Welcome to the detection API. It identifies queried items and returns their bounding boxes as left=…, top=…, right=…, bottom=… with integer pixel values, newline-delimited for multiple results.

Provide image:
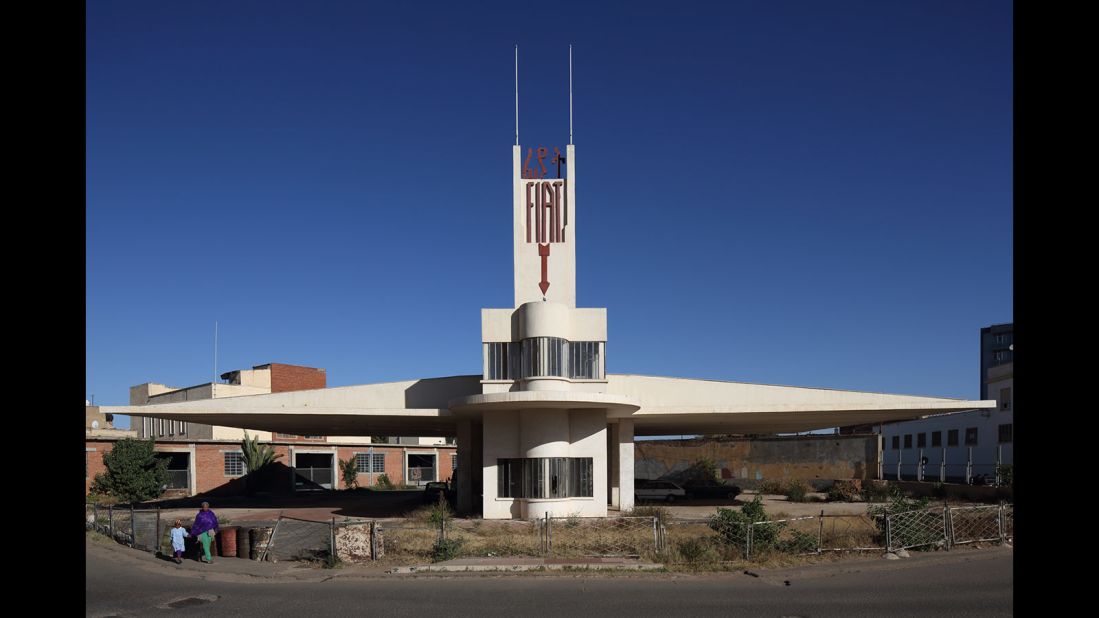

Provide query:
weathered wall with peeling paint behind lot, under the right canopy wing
left=634, top=435, right=878, bottom=485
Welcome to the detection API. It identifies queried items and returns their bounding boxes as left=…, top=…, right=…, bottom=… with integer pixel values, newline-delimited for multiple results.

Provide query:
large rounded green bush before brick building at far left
left=91, top=438, right=168, bottom=503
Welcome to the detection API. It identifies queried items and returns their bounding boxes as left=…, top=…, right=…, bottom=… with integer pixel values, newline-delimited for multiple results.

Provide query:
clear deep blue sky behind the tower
left=86, top=0, right=1013, bottom=424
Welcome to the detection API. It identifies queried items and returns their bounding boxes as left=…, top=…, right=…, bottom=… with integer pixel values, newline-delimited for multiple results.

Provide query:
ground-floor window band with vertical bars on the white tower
left=497, top=457, right=595, bottom=498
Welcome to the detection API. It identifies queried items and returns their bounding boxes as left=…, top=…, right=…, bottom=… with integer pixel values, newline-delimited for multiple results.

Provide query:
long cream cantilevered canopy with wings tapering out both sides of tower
left=100, top=374, right=996, bottom=437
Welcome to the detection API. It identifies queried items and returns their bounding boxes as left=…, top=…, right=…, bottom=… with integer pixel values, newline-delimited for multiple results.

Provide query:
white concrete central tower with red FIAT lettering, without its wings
left=451, top=136, right=637, bottom=519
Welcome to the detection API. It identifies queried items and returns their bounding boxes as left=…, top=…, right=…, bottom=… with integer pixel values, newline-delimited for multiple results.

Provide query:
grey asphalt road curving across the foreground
left=86, top=547, right=1012, bottom=618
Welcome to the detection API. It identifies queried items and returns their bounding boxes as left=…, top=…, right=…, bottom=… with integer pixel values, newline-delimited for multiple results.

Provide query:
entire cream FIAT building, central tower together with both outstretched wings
left=101, top=136, right=996, bottom=519
